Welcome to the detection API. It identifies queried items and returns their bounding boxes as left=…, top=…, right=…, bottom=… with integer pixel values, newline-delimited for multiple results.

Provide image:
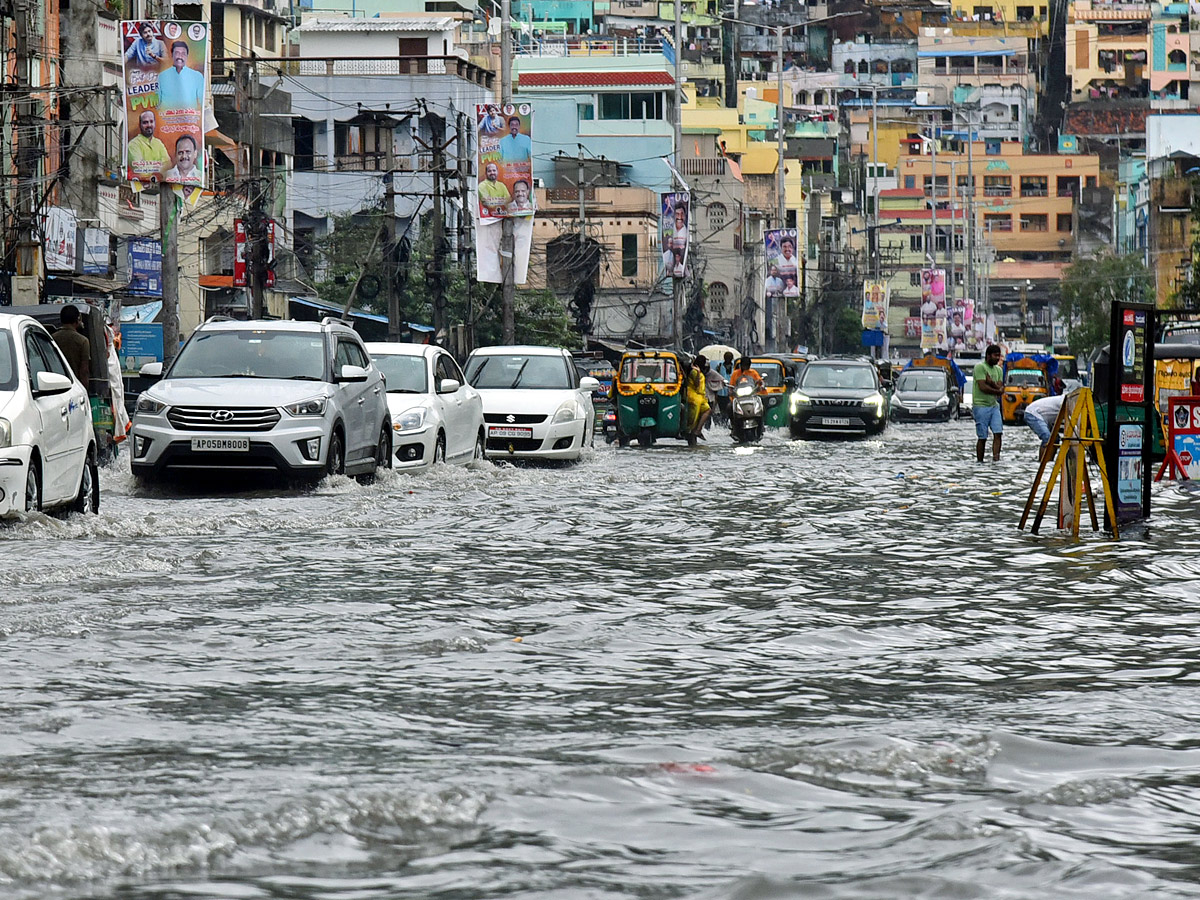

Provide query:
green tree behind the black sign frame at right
left=1060, top=254, right=1154, bottom=354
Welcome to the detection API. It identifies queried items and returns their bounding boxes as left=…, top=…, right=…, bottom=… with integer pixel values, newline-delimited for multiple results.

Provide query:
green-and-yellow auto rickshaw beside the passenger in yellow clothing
left=612, top=350, right=696, bottom=448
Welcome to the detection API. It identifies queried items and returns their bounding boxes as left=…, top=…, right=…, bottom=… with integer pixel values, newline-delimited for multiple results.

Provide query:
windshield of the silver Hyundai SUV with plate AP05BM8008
left=169, top=329, right=325, bottom=382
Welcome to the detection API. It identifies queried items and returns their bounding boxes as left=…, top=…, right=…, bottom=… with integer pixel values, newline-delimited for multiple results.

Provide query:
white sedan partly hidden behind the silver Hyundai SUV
left=366, top=343, right=484, bottom=469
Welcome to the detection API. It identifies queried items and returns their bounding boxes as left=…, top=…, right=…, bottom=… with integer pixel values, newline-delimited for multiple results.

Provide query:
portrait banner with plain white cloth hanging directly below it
left=475, top=103, right=535, bottom=222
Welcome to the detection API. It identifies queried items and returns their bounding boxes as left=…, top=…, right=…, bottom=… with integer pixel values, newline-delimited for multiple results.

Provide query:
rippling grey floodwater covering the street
left=0, top=421, right=1200, bottom=900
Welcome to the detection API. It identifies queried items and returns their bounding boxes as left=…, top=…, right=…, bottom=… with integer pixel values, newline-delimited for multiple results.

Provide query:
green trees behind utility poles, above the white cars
left=316, top=211, right=580, bottom=347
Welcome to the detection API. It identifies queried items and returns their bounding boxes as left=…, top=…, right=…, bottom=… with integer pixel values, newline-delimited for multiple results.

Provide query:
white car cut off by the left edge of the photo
left=0, top=314, right=100, bottom=517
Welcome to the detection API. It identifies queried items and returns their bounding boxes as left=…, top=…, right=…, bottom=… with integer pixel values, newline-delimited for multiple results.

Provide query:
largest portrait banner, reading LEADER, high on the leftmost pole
left=121, top=19, right=209, bottom=187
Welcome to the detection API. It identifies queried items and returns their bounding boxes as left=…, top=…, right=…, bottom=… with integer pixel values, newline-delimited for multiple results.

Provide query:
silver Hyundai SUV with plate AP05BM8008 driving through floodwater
left=130, top=317, right=391, bottom=479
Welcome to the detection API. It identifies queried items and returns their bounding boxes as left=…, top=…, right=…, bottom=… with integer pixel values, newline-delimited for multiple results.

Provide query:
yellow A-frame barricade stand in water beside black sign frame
left=1016, top=388, right=1120, bottom=538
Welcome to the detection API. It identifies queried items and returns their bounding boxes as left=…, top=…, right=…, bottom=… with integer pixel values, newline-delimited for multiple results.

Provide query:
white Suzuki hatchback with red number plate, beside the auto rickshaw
left=467, top=347, right=600, bottom=460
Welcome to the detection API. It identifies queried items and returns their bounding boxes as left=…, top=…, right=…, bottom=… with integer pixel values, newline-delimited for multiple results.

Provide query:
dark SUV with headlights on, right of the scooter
left=788, top=359, right=888, bottom=438
